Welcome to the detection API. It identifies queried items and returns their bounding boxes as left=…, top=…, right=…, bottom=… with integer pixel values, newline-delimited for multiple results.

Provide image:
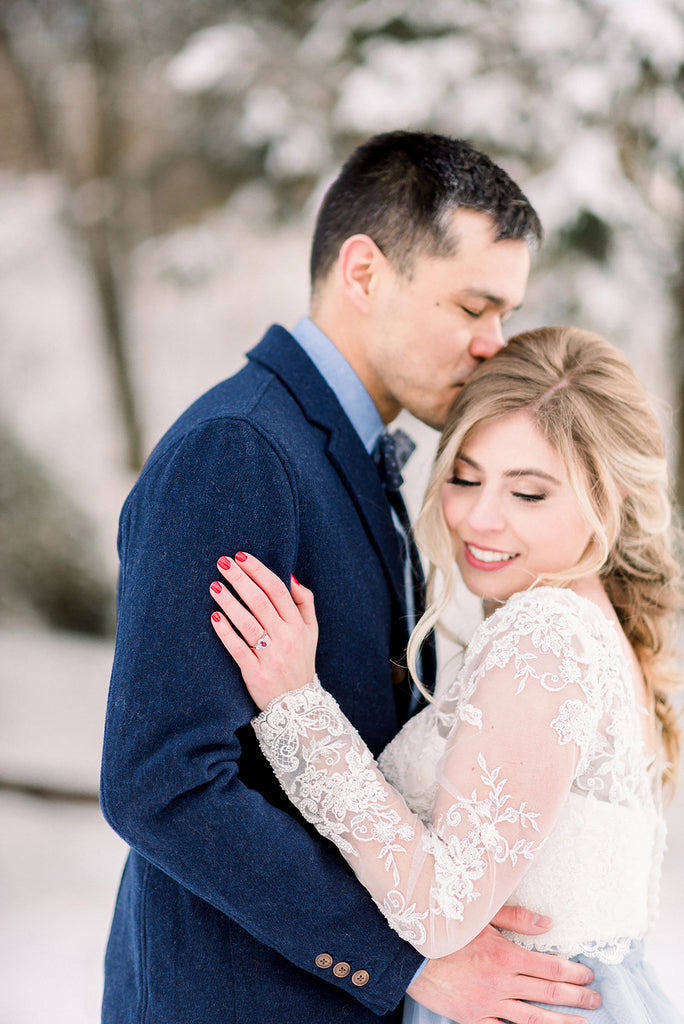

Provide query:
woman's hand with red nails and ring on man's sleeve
left=210, top=551, right=318, bottom=711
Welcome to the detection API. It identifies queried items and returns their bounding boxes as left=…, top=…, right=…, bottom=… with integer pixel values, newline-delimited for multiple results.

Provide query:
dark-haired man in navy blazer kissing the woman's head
left=102, top=132, right=595, bottom=1024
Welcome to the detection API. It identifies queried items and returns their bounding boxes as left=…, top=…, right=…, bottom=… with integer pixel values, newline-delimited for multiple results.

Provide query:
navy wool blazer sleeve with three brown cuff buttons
left=101, top=419, right=422, bottom=1013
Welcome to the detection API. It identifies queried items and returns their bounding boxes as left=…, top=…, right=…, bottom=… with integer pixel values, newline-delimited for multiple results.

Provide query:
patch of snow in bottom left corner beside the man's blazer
left=0, top=793, right=126, bottom=1024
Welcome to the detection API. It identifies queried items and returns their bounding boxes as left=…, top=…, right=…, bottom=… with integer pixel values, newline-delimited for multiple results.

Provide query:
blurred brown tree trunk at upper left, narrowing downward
left=0, top=0, right=142, bottom=470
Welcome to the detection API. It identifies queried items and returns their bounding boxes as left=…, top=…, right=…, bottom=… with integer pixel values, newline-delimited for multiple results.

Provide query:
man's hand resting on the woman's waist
left=409, top=906, right=601, bottom=1024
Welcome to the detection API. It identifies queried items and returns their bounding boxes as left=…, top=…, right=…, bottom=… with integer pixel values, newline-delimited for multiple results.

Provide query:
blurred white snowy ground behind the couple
left=0, top=175, right=684, bottom=1024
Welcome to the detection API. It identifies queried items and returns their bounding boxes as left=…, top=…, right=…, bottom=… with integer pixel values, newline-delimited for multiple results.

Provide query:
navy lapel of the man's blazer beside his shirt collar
left=248, top=326, right=405, bottom=611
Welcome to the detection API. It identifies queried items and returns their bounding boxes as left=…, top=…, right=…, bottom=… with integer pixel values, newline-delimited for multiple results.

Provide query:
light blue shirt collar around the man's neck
left=290, top=316, right=385, bottom=455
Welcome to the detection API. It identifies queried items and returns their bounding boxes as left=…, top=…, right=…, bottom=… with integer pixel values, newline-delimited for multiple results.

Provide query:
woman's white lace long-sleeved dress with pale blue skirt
left=254, top=587, right=680, bottom=1024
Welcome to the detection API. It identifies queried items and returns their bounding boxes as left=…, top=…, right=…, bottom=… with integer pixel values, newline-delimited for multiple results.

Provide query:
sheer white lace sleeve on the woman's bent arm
left=254, top=589, right=596, bottom=957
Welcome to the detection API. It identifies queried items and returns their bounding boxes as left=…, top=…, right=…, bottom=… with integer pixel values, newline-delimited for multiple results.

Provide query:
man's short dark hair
left=310, top=131, right=542, bottom=288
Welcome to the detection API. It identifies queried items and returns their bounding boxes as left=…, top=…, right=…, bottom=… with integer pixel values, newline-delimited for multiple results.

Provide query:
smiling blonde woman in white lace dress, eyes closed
left=206, top=328, right=680, bottom=1024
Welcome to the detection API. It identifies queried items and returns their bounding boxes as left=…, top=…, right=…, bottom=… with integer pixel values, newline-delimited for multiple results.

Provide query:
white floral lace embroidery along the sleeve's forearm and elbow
left=255, top=680, right=543, bottom=944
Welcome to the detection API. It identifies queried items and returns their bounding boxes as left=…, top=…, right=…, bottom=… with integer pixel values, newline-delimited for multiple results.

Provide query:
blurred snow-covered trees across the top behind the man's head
left=4, top=0, right=684, bottom=491
